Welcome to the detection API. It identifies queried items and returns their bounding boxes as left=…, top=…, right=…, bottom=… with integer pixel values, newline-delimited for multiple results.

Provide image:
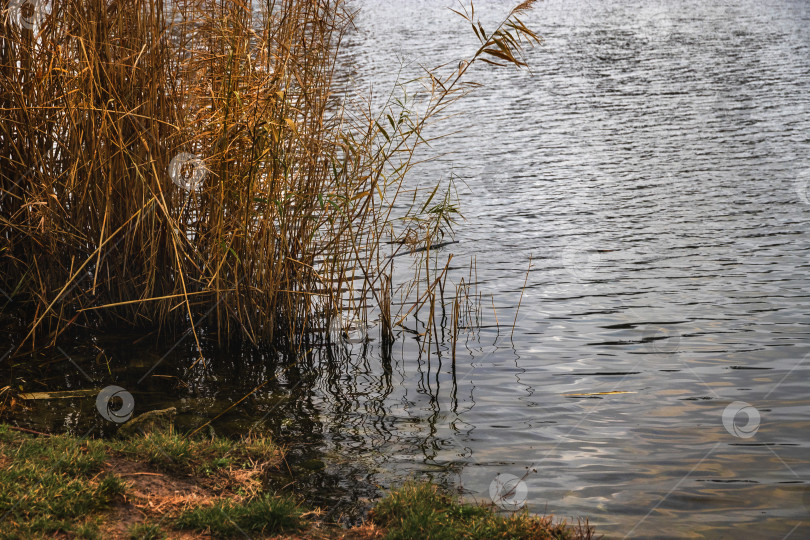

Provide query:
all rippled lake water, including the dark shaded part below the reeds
left=6, top=0, right=810, bottom=539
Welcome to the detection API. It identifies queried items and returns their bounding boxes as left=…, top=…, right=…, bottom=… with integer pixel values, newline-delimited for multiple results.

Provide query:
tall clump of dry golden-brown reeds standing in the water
left=0, top=0, right=538, bottom=351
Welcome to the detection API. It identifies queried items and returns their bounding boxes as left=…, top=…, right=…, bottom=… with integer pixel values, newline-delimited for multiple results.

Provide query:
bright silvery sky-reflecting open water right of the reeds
left=334, top=0, right=810, bottom=538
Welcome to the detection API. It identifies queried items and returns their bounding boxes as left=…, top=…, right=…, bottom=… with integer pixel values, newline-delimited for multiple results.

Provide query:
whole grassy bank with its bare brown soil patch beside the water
left=0, top=425, right=591, bottom=540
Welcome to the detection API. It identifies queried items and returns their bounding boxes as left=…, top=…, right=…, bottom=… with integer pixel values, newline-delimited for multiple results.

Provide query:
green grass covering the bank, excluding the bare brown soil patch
left=0, top=424, right=592, bottom=540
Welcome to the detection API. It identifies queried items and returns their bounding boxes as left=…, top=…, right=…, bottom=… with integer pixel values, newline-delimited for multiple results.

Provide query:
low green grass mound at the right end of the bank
left=371, top=483, right=591, bottom=540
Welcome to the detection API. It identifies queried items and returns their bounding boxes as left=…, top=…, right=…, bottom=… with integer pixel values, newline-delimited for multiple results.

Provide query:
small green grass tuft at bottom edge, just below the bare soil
left=174, top=494, right=302, bottom=538
